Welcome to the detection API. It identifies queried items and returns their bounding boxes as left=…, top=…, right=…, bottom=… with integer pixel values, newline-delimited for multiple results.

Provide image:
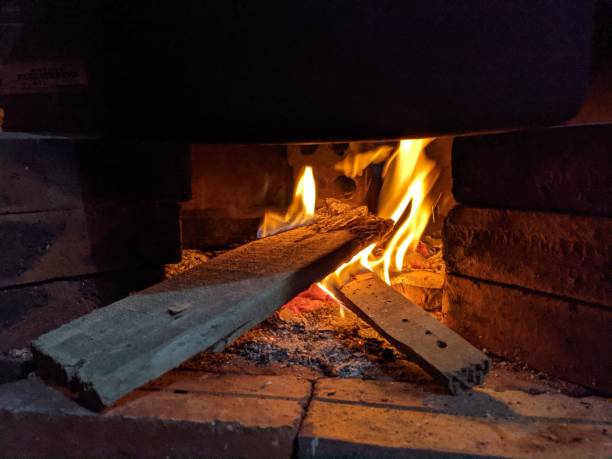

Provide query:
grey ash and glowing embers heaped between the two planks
left=225, top=302, right=429, bottom=380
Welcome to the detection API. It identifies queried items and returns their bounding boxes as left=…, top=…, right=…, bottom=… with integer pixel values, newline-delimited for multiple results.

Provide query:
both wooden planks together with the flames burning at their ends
left=33, top=135, right=489, bottom=407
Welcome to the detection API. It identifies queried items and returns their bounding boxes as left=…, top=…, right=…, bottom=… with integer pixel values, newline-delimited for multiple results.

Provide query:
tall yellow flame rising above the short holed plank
left=321, top=139, right=439, bottom=296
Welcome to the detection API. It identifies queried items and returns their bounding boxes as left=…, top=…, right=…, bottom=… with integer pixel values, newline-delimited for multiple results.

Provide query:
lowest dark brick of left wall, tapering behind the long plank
left=0, top=268, right=163, bottom=353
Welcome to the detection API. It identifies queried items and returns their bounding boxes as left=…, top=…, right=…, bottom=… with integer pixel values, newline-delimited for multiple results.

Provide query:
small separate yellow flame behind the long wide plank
left=257, top=166, right=317, bottom=237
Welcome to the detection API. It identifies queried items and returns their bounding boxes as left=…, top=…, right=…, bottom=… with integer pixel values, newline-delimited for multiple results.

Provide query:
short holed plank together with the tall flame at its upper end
left=310, top=139, right=489, bottom=393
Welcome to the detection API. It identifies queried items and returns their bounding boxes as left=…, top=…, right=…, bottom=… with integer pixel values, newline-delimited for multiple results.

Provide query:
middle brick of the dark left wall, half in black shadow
left=0, top=203, right=181, bottom=287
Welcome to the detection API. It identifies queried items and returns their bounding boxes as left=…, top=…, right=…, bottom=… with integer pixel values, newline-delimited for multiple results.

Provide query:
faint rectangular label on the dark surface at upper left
left=0, top=62, right=87, bottom=96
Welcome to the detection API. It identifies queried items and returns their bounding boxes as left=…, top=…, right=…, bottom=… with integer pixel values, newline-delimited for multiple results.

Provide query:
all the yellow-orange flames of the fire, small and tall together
left=258, top=139, right=440, bottom=317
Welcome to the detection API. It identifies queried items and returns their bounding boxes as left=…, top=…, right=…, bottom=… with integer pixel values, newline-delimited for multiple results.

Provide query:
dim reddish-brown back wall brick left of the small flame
left=181, top=144, right=293, bottom=249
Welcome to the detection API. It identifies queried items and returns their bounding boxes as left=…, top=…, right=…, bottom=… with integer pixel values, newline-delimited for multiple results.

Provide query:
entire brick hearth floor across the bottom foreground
left=0, top=369, right=612, bottom=458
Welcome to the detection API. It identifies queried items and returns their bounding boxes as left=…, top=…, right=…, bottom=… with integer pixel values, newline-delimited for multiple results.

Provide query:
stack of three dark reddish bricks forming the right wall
left=443, top=125, right=612, bottom=392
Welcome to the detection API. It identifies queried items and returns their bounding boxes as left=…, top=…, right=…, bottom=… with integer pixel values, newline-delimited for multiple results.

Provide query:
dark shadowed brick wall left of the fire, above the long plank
left=0, top=133, right=191, bottom=379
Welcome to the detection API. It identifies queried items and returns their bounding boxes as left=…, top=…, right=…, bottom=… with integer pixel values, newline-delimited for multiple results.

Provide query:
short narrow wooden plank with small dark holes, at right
left=339, top=274, right=490, bottom=394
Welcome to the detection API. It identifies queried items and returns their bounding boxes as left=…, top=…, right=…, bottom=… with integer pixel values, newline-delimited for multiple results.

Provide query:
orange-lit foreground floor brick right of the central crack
left=298, top=379, right=612, bottom=458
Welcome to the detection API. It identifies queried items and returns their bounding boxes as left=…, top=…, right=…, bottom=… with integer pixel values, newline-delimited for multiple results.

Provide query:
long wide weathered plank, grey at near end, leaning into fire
left=33, top=212, right=389, bottom=407
